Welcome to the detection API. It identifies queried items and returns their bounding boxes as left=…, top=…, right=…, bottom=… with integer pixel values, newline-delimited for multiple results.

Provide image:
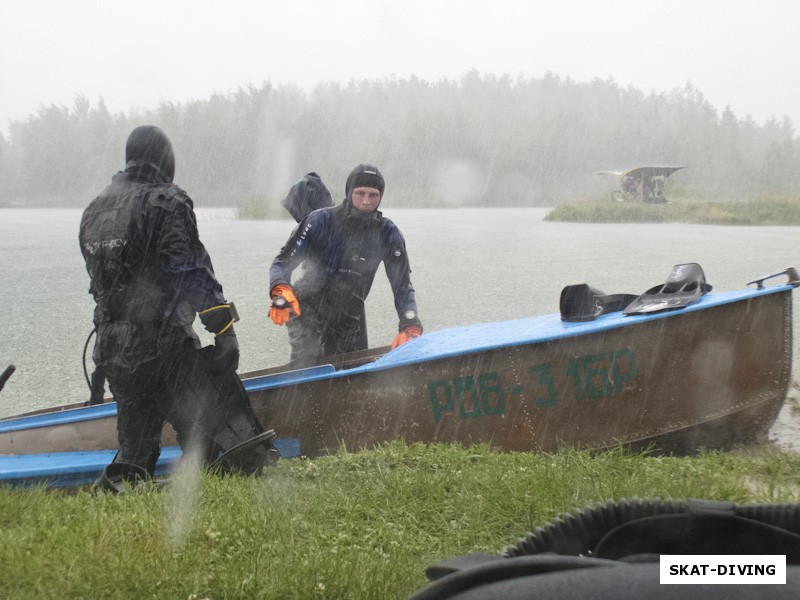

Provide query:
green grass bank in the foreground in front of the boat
left=0, top=443, right=800, bottom=599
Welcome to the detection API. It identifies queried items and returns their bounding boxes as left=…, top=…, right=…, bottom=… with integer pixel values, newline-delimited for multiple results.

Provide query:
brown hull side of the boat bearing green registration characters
left=250, top=292, right=792, bottom=456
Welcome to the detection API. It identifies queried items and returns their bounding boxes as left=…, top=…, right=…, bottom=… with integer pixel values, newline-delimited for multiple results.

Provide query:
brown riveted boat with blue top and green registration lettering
left=0, top=269, right=797, bottom=490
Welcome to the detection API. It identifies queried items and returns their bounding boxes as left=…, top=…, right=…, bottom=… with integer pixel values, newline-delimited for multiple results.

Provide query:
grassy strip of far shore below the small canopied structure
left=545, top=196, right=800, bottom=225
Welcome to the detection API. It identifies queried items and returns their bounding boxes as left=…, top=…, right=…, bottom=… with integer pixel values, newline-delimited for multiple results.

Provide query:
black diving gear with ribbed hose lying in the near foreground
left=410, top=498, right=800, bottom=600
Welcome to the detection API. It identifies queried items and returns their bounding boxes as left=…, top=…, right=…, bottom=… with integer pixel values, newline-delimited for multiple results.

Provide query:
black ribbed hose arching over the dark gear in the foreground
left=504, top=498, right=800, bottom=558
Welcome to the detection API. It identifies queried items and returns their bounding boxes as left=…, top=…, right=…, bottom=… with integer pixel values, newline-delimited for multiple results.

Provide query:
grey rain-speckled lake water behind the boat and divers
left=0, top=206, right=800, bottom=451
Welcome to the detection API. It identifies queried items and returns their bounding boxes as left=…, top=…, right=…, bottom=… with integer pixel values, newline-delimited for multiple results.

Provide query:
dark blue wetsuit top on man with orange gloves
left=270, top=199, right=421, bottom=331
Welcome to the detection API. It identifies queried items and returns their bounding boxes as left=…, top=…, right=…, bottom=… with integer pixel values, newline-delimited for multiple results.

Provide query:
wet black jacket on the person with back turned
left=79, top=160, right=225, bottom=371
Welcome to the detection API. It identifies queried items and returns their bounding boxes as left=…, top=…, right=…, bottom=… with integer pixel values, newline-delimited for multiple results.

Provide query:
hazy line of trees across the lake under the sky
left=0, top=71, right=800, bottom=207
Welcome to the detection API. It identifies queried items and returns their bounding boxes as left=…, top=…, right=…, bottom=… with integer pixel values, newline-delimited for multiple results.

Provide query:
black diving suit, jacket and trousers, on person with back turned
left=79, top=161, right=225, bottom=474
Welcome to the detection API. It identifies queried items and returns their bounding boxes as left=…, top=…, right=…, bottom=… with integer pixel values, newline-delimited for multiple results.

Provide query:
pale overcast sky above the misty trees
left=0, top=0, right=800, bottom=132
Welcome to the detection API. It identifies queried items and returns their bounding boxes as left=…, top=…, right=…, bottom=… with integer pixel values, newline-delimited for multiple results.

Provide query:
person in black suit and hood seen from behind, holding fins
left=79, top=126, right=272, bottom=476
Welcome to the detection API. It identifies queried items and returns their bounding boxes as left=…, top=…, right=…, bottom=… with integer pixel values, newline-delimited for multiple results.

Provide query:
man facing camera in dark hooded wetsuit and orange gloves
left=270, top=164, right=422, bottom=367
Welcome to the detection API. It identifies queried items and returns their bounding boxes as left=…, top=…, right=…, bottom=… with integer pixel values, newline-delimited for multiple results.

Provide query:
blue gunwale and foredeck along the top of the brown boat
left=0, top=284, right=794, bottom=433
